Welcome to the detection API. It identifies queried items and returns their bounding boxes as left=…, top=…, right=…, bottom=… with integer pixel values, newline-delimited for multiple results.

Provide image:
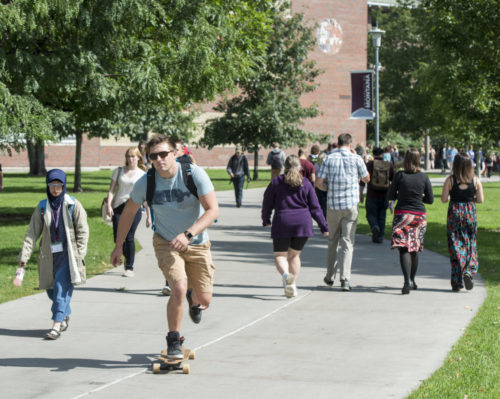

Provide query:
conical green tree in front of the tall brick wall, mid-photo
left=201, top=4, right=320, bottom=179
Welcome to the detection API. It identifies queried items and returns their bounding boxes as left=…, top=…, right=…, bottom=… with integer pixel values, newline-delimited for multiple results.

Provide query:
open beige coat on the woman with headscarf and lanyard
left=18, top=194, right=89, bottom=290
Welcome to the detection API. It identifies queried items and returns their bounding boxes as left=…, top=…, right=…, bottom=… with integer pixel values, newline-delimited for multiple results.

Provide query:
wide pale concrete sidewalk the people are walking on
left=0, top=189, right=486, bottom=399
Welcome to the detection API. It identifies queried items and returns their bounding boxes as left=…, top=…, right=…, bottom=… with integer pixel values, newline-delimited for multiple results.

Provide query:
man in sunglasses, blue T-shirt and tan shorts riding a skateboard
left=110, top=134, right=219, bottom=359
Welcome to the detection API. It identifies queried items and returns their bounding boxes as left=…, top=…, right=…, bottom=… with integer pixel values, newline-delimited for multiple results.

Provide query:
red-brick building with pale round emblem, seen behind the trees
left=0, top=0, right=396, bottom=170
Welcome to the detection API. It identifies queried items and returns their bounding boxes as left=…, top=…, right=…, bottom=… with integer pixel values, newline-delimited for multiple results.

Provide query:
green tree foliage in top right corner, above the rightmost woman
left=422, top=0, right=500, bottom=144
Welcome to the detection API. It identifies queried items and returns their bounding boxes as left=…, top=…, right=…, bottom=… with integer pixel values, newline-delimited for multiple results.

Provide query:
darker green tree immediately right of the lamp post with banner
left=368, top=0, right=437, bottom=142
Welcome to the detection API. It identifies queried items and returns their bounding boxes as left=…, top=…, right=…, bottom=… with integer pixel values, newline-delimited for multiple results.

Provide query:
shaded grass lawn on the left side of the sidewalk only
left=0, top=169, right=271, bottom=303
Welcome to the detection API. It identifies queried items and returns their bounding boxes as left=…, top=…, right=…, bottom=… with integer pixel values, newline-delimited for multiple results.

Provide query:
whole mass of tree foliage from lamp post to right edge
left=369, top=0, right=500, bottom=144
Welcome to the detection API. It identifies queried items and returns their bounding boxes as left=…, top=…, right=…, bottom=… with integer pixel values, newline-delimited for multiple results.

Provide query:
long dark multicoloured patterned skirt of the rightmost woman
left=446, top=201, right=479, bottom=289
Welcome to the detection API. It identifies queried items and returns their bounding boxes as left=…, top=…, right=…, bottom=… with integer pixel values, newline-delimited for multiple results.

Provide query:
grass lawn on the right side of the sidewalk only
left=357, top=183, right=500, bottom=399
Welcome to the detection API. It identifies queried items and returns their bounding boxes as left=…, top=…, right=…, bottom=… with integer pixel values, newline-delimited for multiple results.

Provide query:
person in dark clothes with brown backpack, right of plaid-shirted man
left=365, top=147, right=394, bottom=244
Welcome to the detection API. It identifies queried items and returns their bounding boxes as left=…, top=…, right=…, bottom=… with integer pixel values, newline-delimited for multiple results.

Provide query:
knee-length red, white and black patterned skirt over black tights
left=391, top=213, right=427, bottom=252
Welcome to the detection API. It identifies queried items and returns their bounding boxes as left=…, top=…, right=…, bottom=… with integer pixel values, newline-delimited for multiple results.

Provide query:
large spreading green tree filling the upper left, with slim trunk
left=0, top=0, right=271, bottom=187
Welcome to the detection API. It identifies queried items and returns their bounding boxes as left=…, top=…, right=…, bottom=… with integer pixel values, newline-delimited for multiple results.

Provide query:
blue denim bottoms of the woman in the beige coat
left=47, top=258, right=73, bottom=322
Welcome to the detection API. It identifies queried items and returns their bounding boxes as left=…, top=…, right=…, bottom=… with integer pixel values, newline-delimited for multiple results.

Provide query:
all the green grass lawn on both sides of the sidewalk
left=0, top=169, right=500, bottom=399
